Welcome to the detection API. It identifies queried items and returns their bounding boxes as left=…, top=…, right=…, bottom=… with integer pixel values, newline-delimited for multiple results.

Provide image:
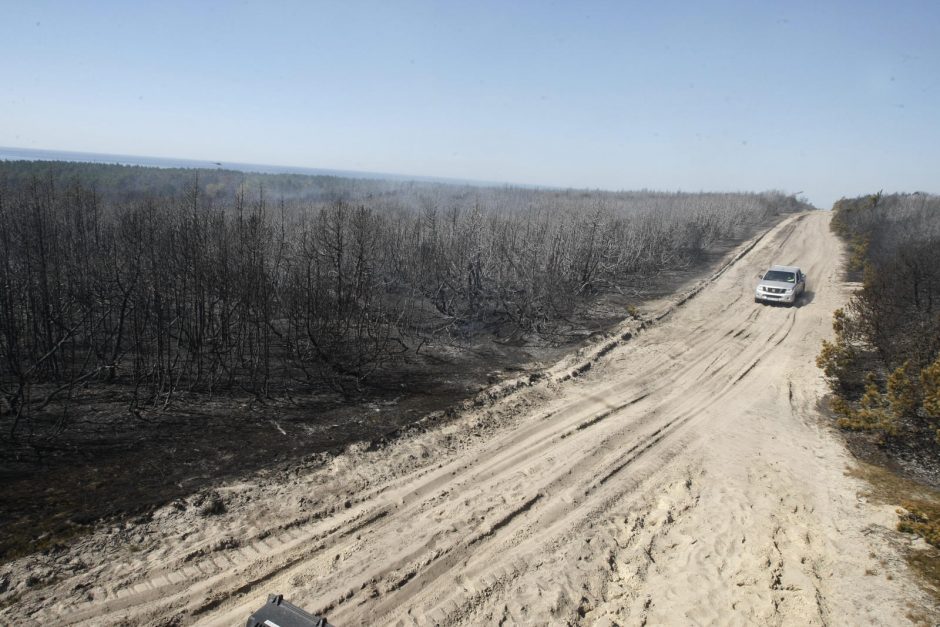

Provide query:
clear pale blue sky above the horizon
left=0, top=0, right=940, bottom=208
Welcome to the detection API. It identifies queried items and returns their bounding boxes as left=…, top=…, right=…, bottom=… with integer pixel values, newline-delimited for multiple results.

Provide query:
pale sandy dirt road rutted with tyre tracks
left=0, top=212, right=936, bottom=626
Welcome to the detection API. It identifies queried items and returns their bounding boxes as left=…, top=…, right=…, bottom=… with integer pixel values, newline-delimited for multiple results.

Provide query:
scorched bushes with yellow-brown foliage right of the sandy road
left=817, top=193, right=940, bottom=450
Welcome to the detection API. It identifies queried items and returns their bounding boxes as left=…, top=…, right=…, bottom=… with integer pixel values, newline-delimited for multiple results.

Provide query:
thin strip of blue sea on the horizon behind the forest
left=0, top=146, right=492, bottom=186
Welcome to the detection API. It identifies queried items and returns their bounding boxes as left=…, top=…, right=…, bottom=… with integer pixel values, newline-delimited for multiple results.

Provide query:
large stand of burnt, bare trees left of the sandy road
left=0, top=162, right=808, bottom=440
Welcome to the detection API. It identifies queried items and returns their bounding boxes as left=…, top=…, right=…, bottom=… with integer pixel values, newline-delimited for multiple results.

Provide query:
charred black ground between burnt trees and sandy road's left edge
left=0, top=232, right=756, bottom=563
